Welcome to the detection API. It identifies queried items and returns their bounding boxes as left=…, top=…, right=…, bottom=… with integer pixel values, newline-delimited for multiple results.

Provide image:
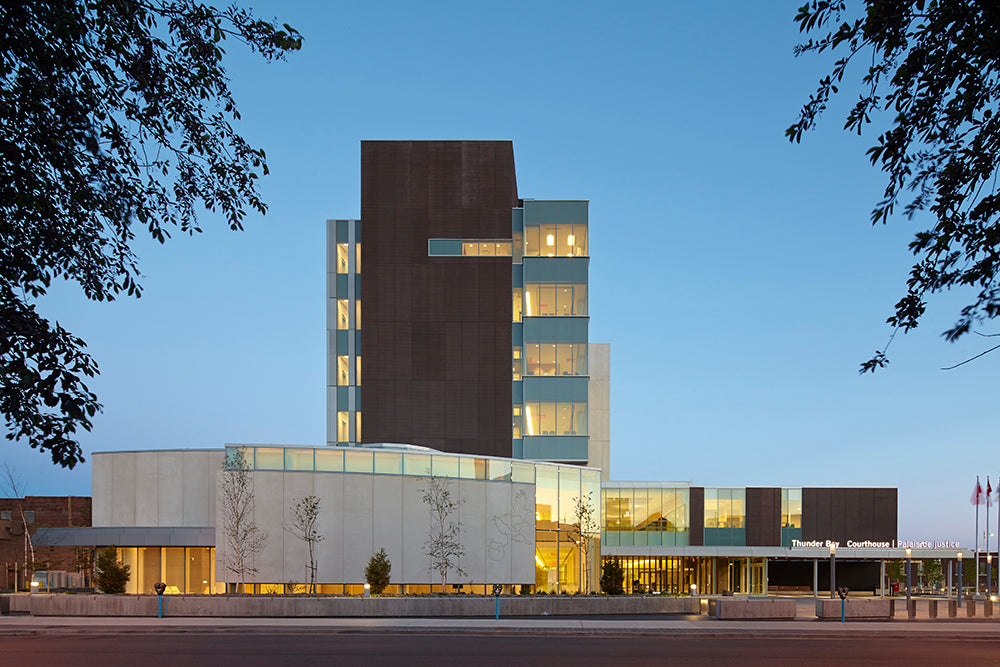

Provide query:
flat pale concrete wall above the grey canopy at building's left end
left=91, top=449, right=224, bottom=528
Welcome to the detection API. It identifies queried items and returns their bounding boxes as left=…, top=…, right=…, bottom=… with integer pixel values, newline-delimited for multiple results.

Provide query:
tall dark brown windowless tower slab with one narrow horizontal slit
left=360, top=141, right=518, bottom=456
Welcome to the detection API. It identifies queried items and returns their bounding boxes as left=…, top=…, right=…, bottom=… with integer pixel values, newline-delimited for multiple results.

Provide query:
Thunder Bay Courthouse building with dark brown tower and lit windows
left=41, top=141, right=936, bottom=594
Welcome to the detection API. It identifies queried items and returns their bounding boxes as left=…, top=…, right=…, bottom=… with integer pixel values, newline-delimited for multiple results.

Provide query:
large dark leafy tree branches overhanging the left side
left=0, top=0, right=302, bottom=468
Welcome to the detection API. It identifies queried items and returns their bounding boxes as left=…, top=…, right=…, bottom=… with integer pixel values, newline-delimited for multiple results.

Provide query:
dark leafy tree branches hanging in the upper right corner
left=786, top=0, right=1000, bottom=373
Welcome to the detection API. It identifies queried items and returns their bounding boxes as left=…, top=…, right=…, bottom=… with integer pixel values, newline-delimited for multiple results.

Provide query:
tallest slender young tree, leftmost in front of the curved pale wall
left=220, top=449, right=267, bottom=592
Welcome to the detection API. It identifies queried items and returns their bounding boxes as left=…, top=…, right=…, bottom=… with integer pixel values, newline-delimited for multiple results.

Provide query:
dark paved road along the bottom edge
left=0, top=631, right=1000, bottom=667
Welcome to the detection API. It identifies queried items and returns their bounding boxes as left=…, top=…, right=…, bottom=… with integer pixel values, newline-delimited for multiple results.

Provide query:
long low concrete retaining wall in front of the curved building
left=23, top=594, right=701, bottom=617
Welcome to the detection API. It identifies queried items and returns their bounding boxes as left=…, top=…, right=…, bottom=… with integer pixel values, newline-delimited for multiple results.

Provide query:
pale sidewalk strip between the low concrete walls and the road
left=0, top=616, right=1000, bottom=640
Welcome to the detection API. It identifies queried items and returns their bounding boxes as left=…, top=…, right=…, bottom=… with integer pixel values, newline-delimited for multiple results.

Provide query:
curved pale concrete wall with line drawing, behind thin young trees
left=215, top=471, right=535, bottom=584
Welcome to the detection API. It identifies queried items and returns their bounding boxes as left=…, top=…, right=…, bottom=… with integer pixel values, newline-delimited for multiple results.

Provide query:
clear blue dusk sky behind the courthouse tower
left=0, top=0, right=1000, bottom=546
